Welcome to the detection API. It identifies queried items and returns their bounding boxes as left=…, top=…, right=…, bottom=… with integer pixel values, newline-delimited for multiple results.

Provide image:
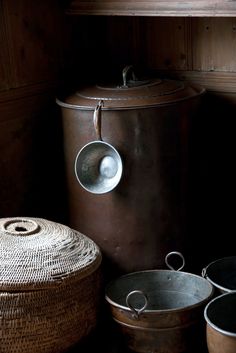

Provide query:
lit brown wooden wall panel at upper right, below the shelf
left=192, top=18, right=236, bottom=72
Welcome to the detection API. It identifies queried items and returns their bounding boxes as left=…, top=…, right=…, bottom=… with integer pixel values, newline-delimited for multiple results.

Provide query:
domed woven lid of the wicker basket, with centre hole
left=0, top=217, right=101, bottom=291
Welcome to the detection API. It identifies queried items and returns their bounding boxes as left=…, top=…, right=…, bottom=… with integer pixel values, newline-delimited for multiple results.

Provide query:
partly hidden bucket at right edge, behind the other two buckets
left=202, top=256, right=236, bottom=294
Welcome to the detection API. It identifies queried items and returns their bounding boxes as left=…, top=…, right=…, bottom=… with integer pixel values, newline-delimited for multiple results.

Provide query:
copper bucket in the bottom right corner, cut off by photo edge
left=204, top=291, right=236, bottom=353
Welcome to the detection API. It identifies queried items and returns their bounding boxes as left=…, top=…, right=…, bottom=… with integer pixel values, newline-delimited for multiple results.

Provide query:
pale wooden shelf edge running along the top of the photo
left=66, top=0, right=236, bottom=17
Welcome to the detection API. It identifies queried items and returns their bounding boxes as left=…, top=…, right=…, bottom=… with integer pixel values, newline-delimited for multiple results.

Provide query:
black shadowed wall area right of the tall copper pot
left=188, top=93, right=236, bottom=273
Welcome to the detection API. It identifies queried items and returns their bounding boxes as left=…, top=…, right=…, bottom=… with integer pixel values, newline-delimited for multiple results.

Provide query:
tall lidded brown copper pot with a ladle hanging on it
left=57, top=67, right=204, bottom=274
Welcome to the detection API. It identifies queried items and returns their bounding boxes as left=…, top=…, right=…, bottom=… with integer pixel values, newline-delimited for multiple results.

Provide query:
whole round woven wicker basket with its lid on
left=0, top=217, right=101, bottom=353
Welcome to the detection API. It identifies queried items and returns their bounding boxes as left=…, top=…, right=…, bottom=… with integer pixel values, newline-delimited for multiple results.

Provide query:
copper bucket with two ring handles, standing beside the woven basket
left=105, top=252, right=214, bottom=353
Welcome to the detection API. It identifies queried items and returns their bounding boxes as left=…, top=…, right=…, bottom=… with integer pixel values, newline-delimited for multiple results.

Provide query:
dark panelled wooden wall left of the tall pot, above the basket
left=0, top=0, right=70, bottom=222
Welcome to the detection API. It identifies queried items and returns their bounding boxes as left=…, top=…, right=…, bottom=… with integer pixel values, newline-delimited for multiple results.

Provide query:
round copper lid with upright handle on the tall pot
left=57, top=66, right=205, bottom=109
